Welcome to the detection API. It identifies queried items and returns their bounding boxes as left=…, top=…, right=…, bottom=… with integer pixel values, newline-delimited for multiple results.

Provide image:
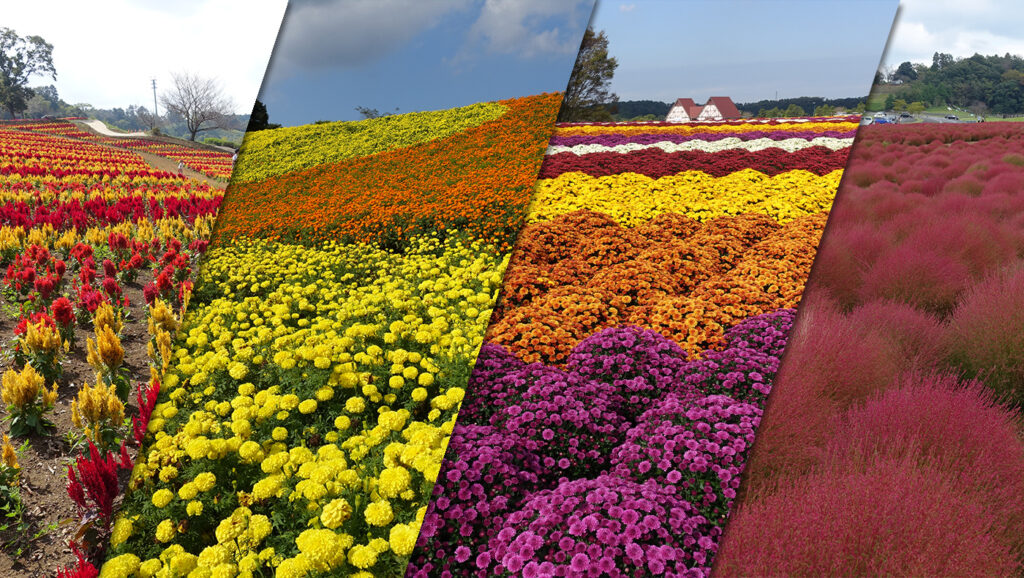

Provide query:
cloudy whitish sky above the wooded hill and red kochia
left=884, top=0, right=1024, bottom=67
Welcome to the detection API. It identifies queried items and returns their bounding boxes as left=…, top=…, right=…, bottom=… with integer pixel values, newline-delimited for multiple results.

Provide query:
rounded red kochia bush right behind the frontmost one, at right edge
left=825, top=372, right=1024, bottom=553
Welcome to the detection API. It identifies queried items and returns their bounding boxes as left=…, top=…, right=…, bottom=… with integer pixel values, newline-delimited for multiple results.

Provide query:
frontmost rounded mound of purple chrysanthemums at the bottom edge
left=487, top=474, right=721, bottom=578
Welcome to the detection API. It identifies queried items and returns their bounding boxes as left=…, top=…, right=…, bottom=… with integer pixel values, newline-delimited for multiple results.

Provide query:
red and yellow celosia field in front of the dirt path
left=0, top=123, right=222, bottom=569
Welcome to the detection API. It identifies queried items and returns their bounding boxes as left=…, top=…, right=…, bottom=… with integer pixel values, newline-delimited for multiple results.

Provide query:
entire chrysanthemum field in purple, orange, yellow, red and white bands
left=408, top=117, right=857, bottom=577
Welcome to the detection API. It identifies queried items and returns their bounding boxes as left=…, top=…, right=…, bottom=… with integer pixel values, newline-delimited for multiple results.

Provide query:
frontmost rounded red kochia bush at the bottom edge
left=714, top=459, right=1021, bottom=578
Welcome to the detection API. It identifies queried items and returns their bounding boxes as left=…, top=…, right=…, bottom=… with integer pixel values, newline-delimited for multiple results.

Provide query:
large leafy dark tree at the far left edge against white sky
left=0, top=28, right=57, bottom=118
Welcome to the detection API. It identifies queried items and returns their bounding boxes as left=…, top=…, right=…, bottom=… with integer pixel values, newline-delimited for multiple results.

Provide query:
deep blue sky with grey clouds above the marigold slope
left=260, top=0, right=594, bottom=126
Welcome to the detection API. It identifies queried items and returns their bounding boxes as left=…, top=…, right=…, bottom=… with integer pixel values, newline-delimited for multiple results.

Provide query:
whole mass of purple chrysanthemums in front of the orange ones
left=407, top=309, right=794, bottom=578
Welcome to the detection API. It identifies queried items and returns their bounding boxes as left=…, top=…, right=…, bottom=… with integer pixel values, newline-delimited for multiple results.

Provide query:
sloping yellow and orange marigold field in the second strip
left=102, top=94, right=560, bottom=578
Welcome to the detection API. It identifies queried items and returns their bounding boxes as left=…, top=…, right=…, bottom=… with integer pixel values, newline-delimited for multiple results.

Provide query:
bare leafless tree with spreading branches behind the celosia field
left=160, top=73, right=234, bottom=140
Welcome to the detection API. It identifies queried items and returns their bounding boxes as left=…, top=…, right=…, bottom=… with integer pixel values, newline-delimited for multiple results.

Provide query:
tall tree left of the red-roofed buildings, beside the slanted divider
left=558, top=27, right=618, bottom=122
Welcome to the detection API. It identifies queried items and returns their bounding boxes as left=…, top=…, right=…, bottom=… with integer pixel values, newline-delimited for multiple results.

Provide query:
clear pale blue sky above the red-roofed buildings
left=592, top=0, right=897, bottom=104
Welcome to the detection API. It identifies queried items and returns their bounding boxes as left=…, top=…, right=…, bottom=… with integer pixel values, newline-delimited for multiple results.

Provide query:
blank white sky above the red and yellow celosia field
left=0, top=0, right=288, bottom=114
